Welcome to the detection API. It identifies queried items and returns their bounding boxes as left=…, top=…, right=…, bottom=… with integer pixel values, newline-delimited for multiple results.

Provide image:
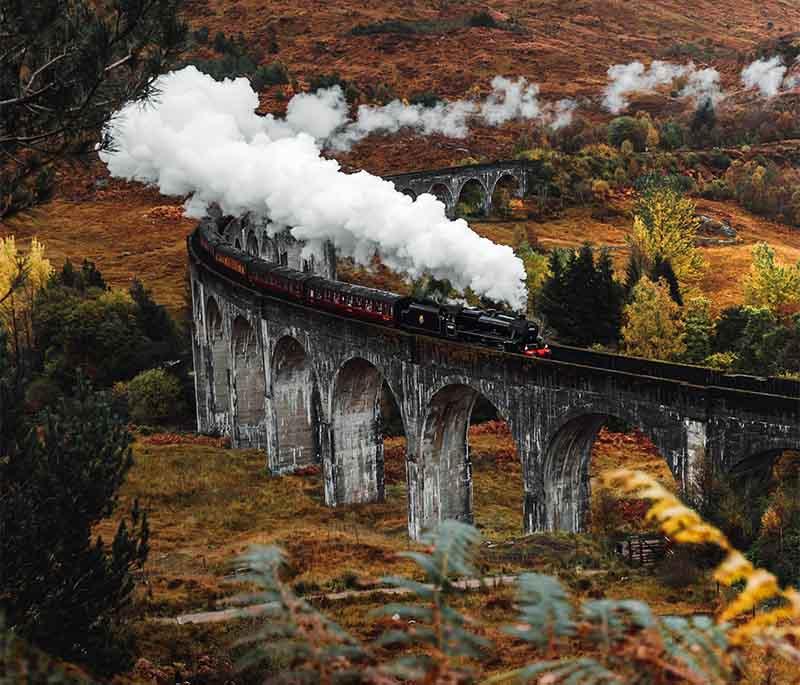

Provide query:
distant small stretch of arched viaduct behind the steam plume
left=384, top=160, right=540, bottom=217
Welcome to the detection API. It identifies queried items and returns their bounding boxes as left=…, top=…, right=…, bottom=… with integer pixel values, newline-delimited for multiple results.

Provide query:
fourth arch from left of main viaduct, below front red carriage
left=330, top=357, right=396, bottom=504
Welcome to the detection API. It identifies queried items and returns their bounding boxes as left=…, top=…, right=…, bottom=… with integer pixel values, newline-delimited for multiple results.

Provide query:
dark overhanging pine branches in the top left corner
left=0, top=0, right=185, bottom=217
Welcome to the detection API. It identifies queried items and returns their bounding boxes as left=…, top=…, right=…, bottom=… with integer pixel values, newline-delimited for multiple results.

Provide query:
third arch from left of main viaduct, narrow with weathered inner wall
left=270, top=335, right=321, bottom=472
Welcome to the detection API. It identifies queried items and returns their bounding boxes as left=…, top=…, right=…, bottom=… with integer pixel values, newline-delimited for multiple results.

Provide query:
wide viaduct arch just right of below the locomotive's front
left=528, top=403, right=687, bottom=533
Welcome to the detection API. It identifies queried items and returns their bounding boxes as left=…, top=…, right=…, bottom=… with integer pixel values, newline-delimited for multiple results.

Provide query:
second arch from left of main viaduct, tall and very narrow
left=231, top=316, right=266, bottom=440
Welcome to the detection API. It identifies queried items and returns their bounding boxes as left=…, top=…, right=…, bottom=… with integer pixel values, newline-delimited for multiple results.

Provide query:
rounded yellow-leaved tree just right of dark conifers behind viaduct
left=622, top=277, right=686, bottom=361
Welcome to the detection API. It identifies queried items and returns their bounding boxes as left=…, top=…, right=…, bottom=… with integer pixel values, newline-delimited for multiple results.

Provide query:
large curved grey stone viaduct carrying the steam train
left=189, top=203, right=800, bottom=539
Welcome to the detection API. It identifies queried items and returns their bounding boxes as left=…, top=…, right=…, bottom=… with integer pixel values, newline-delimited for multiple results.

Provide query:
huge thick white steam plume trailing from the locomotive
left=100, top=67, right=525, bottom=309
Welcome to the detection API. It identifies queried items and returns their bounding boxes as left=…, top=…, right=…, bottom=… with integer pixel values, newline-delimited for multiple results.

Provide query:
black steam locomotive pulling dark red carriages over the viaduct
left=194, top=222, right=550, bottom=357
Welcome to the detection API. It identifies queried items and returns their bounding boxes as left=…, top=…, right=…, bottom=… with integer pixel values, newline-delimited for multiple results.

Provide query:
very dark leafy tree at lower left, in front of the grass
left=0, top=376, right=148, bottom=673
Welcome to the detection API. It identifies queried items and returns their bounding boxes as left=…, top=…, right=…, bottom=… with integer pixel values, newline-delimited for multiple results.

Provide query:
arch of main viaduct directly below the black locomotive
left=419, top=382, right=521, bottom=528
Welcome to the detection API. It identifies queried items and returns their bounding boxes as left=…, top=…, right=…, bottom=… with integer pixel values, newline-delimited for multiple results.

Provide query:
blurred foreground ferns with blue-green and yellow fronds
left=234, top=471, right=800, bottom=685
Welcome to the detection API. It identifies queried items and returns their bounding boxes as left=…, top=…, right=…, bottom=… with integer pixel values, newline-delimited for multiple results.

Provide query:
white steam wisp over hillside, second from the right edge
left=603, top=60, right=724, bottom=114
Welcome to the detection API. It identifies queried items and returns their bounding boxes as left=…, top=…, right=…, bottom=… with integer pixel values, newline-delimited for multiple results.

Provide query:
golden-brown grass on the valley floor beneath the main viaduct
left=111, top=422, right=736, bottom=673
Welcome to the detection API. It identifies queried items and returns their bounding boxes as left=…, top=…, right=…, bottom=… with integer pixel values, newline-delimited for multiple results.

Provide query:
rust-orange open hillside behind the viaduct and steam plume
left=6, top=0, right=800, bottom=310
